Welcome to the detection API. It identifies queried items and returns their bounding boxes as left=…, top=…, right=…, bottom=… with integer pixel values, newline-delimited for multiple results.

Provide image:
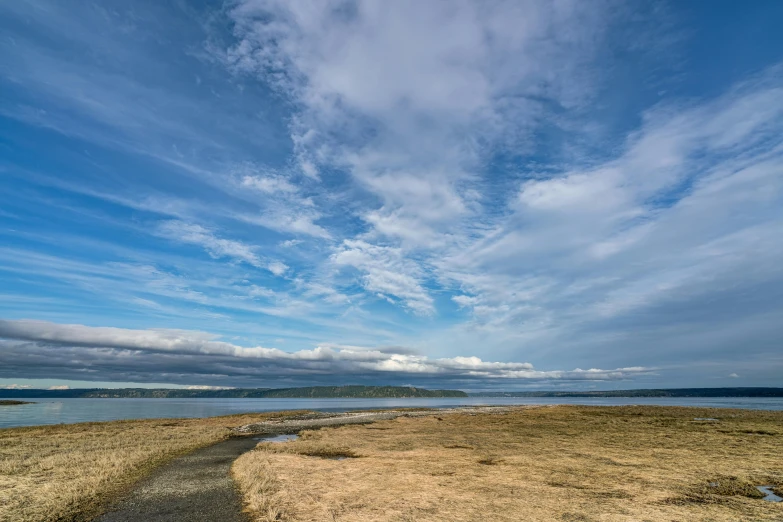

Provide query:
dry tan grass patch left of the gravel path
left=0, top=412, right=310, bottom=522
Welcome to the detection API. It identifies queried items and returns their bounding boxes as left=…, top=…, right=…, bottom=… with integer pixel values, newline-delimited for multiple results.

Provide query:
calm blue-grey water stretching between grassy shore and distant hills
left=0, top=397, right=783, bottom=428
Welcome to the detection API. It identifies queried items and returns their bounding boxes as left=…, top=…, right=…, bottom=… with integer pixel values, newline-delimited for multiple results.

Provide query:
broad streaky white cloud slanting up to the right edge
left=433, top=69, right=783, bottom=344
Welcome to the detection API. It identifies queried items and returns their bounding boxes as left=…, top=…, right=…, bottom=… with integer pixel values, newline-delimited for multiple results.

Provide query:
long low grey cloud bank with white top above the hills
left=0, top=320, right=650, bottom=386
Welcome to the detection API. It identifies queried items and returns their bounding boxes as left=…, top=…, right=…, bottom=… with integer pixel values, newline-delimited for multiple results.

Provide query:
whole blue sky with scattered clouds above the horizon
left=0, top=0, right=783, bottom=391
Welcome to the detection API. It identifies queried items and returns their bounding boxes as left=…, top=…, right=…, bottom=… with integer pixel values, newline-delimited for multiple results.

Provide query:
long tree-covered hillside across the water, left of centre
left=0, top=386, right=468, bottom=399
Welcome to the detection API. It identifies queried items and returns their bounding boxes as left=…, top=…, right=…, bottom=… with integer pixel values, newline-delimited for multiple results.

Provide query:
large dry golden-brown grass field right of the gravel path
left=233, top=406, right=783, bottom=522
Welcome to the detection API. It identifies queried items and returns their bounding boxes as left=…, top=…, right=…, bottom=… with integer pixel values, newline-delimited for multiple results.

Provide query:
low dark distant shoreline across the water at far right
left=470, top=388, right=783, bottom=397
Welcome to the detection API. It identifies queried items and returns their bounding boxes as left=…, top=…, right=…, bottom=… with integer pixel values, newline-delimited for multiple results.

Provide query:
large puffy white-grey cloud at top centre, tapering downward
left=220, top=0, right=611, bottom=248
